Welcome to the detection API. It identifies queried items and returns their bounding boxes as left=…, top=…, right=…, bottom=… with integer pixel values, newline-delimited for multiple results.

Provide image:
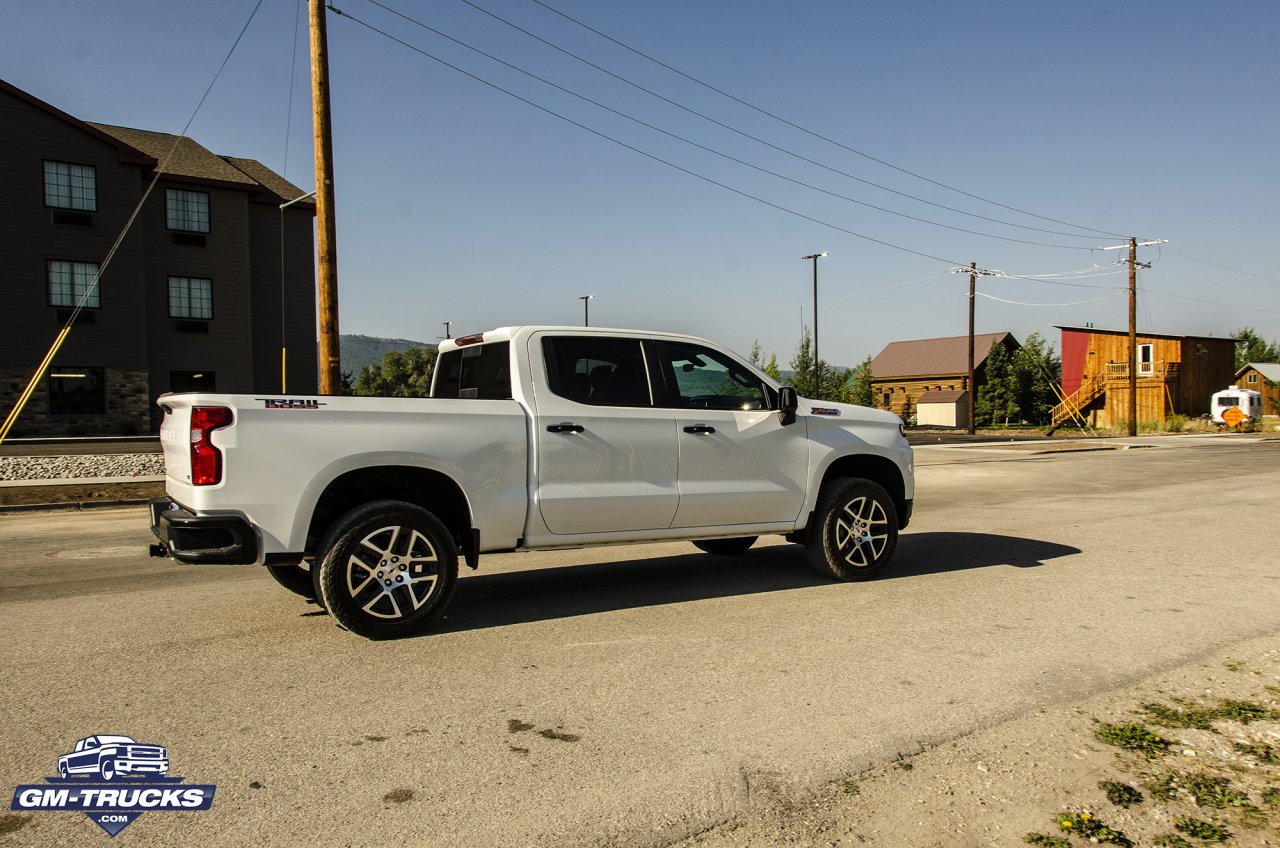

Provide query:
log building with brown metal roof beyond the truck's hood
left=872, top=333, right=1021, bottom=427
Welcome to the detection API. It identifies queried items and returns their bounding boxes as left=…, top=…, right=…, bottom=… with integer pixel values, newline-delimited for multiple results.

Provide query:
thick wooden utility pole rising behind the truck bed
left=307, top=0, right=342, bottom=395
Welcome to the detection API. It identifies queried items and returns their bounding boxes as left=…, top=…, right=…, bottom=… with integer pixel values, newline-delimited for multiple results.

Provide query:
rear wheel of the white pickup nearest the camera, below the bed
left=312, top=501, right=458, bottom=639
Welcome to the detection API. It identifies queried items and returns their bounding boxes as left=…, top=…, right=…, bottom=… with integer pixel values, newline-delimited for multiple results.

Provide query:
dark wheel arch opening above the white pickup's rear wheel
left=306, top=465, right=477, bottom=561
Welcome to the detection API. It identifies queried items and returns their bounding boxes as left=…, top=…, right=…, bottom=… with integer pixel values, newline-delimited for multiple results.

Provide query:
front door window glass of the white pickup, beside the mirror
left=662, top=342, right=769, bottom=410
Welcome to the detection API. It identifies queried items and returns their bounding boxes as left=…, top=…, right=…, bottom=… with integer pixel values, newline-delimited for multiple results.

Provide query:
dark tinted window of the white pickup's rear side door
left=543, top=336, right=653, bottom=406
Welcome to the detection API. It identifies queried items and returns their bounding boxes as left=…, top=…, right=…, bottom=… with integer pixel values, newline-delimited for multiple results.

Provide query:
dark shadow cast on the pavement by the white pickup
left=433, top=533, right=1080, bottom=633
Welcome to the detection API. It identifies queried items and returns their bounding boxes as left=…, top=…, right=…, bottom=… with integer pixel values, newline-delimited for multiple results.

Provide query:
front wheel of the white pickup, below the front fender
left=806, top=478, right=897, bottom=580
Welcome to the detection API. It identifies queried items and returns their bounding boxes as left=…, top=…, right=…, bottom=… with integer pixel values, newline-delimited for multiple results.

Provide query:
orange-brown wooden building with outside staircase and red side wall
left=1052, top=327, right=1235, bottom=429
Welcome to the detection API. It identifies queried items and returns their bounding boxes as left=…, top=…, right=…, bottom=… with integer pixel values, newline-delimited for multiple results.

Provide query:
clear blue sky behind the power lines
left=0, top=0, right=1280, bottom=365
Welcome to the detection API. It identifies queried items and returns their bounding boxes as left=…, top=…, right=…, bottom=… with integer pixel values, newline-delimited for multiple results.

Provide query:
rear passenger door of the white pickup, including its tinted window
left=529, top=333, right=680, bottom=535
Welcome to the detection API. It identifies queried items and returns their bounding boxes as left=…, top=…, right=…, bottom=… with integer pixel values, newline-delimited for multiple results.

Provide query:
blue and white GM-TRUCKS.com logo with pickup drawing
left=9, top=733, right=216, bottom=836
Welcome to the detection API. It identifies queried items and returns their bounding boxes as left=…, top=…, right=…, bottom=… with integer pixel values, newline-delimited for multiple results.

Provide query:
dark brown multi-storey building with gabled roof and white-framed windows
left=0, top=81, right=317, bottom=437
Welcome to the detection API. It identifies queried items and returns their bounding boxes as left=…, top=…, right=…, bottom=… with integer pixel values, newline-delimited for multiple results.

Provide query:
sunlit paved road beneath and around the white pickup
left=0, top=437, right=1280, bottom=848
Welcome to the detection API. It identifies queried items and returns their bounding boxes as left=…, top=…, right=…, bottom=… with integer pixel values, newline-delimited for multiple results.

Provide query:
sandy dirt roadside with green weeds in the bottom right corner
left=678, top=639, right=1280, bottom=848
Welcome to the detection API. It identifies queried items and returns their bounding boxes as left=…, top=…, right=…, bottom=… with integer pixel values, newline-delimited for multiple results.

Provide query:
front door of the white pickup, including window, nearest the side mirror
left=650, top=341, right=809, bottom=528
